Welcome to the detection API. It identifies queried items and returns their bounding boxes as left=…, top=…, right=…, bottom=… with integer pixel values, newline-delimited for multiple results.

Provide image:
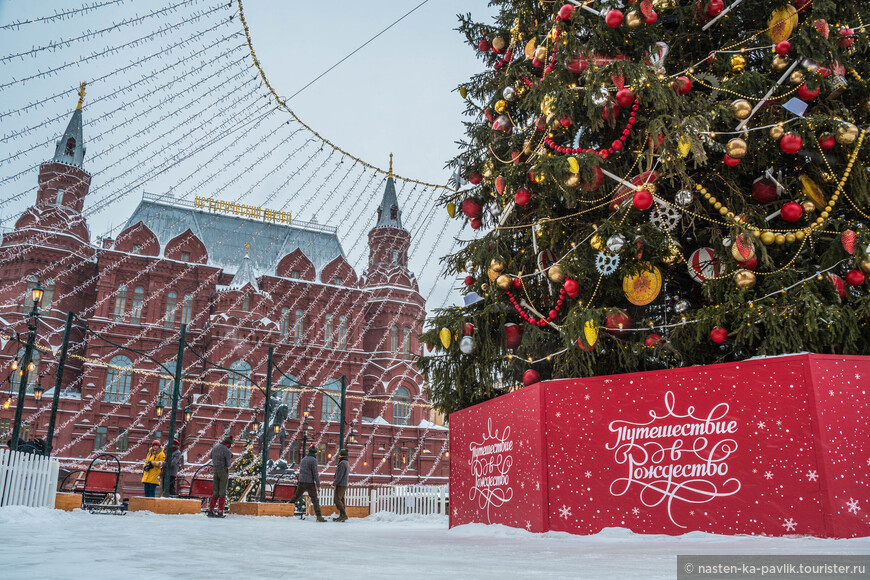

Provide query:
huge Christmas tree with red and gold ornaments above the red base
left=420, top=0, right=870, bottom=413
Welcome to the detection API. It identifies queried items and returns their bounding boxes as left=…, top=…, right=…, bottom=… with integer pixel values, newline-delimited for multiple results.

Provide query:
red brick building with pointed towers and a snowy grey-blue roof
left=0, top=99, right=449, bottom=488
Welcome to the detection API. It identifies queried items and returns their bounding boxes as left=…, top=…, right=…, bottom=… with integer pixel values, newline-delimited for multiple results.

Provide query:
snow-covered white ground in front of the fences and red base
left=0, top=507, right=870, bottom=580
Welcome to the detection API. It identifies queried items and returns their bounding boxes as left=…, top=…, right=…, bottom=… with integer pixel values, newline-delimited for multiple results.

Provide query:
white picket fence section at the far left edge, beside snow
left=0, top=449, right=60, bottom=508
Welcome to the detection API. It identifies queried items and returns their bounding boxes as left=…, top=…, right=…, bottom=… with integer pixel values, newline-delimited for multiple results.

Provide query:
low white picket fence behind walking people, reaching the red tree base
left=317, top=485, right=449, bottom=515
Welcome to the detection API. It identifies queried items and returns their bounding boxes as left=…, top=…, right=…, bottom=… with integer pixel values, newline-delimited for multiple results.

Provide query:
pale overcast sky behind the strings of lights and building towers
left=0, top=0, right=492, bottom=307
